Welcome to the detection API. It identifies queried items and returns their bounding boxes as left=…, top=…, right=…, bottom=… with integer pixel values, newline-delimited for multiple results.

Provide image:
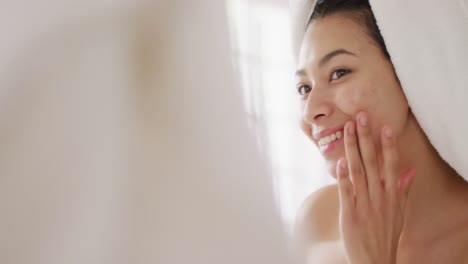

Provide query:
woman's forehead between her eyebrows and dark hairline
left=298, top=14, right=375, bottom=68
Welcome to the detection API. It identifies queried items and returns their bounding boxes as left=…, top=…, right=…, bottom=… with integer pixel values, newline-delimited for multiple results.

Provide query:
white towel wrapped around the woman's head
left=291, top=0, right=468, bottom=180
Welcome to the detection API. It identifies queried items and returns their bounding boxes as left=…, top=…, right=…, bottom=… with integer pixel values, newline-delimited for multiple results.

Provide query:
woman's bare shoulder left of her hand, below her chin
left=295, top=184, right=340, bottom=245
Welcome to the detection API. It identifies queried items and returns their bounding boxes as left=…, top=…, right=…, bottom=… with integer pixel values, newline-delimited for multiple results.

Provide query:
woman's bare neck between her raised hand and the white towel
left=390, top=114, right=468, bottom=238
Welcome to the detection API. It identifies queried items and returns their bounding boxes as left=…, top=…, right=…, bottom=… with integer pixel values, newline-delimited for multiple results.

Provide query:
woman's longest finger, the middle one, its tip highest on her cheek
left=356, top=112, right=382, bottom=202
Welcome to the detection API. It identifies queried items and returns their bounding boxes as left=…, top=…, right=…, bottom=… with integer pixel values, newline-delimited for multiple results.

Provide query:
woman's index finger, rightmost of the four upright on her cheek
left=381, top=126, right=400, bottom=194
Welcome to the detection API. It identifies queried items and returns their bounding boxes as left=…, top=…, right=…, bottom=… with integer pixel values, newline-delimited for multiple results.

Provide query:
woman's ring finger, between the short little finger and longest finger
left=344, top=121, right=369, bottom=203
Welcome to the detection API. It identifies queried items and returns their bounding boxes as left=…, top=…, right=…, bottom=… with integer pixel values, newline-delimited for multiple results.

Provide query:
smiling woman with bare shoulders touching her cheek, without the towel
left=296, top=0, right=468, bottom=264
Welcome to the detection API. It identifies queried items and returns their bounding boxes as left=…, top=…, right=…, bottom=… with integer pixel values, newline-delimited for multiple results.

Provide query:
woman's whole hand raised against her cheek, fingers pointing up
left=337, top=112, right=416, bottom=264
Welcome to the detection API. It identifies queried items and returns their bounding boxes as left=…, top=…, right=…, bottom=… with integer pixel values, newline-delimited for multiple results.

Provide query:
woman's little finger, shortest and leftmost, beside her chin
left=336, top=158, right=354, bottom=214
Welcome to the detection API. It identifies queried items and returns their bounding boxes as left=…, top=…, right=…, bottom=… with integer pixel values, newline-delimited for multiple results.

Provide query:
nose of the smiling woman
left=303, top=87, right=334, bottom=125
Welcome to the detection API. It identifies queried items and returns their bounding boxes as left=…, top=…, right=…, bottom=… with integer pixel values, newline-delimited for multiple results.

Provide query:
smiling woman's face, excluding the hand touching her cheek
left=296, top=14, right=409, bottom=178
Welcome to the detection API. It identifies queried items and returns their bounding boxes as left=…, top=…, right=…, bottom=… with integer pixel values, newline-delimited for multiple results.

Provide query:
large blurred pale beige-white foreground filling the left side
left=0, top=0, right=298, bottom=264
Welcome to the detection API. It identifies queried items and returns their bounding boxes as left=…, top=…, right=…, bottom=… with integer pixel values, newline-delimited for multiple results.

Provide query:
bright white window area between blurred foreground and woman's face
left=227, top=0, right=334, bottom=226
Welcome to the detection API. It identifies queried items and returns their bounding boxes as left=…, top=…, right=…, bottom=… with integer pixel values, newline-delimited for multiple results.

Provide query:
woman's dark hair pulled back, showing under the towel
left=307, top=0, right=390, bottom=60
